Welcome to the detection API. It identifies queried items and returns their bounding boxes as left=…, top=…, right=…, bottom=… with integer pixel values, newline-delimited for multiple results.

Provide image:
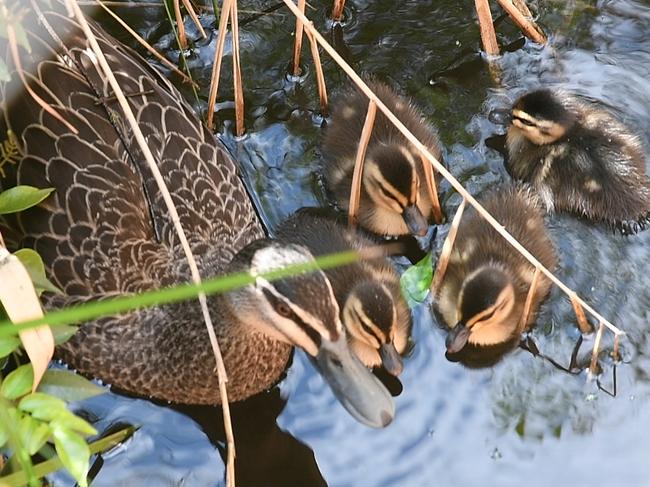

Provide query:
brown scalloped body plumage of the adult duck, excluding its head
left=0, top=8, right=291, bottom=404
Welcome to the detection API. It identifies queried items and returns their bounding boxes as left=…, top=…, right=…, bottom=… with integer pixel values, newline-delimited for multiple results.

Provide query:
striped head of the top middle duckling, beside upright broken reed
left=363, top=144, right=429, bottom=236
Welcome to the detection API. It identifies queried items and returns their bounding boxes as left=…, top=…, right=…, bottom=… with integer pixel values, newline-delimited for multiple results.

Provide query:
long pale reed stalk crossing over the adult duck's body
left=68, top=0, right=235, bottom=487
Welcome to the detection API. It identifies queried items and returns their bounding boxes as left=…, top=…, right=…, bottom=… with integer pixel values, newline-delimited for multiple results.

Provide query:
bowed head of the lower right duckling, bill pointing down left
left=446, top=265, right=518, bottom=362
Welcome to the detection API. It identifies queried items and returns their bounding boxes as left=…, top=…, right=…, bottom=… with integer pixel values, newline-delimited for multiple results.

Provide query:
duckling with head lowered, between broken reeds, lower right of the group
left=435, top=185, right=557, bottom=367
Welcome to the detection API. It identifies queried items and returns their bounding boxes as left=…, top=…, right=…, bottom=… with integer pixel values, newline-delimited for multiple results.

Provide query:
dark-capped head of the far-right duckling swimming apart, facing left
left=510, top=89, right=576, bottom=145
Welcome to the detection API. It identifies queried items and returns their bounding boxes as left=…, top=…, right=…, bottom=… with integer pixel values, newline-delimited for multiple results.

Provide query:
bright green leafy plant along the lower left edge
left=0, top=186, right=104, bottom=486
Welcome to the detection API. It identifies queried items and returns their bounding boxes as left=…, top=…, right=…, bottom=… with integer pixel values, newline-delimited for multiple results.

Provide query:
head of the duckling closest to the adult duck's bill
left=343, top=280, right=406, bottom=376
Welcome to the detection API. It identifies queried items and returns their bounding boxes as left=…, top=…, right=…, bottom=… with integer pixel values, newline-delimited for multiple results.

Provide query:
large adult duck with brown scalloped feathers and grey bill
left=0, top=5, right=394, bottom=427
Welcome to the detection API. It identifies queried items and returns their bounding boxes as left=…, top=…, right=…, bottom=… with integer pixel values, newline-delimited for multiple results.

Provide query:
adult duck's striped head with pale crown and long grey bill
left=227, top=240, right=395, bottom=428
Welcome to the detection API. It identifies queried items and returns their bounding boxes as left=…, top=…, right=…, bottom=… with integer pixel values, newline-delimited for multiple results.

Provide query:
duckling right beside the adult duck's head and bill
left=278, top=208, right=411, bottom=376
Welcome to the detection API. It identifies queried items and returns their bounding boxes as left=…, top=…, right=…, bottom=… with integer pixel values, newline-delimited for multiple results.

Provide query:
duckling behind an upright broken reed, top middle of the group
left=322, top=80, right=441, bottom=236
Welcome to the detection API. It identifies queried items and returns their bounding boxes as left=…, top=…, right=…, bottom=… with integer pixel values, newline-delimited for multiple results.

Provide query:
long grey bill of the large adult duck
left=312, top=334, right=395, bottom=428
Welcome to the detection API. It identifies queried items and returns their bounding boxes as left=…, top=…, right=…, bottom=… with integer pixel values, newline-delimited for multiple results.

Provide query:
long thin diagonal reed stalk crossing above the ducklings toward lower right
left=282, top=0, right=625, bottom=335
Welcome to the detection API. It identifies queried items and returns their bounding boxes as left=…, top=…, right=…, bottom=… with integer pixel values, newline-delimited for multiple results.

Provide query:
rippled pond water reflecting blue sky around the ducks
left=53, top=0, right=650, bottom=487
